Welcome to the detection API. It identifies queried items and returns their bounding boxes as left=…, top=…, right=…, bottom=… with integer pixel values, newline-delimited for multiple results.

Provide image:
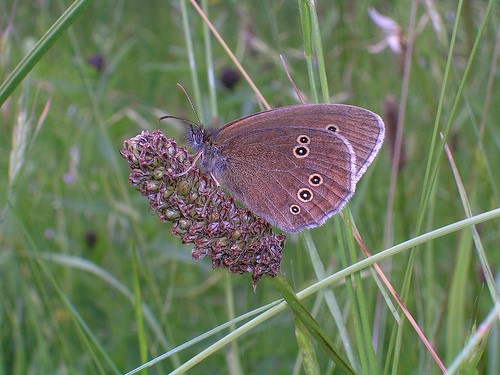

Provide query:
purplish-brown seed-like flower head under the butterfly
left=120, top=130, right=286, bottom=289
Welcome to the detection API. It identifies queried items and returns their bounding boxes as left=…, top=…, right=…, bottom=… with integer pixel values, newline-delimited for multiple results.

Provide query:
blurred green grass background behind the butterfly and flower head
left=0, top=0, right=500, bottom=374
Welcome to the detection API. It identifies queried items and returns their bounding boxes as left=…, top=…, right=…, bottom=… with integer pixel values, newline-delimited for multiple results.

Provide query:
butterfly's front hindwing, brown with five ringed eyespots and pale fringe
left=212, top=125, right=357, bottom=233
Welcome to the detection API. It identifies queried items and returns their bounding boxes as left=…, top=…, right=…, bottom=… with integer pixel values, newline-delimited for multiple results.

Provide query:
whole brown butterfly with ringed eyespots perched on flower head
left=188, top=104, right=384, bottom=233
